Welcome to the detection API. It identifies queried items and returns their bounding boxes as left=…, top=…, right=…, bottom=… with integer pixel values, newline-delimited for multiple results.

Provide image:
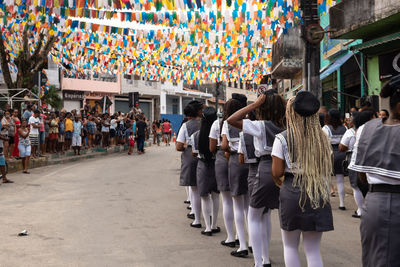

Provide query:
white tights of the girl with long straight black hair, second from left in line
left=201, top=192, right=219, bottom=232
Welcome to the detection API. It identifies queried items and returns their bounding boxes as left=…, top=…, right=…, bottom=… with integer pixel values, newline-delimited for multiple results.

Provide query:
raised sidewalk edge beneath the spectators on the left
left=7, top=140, right=151, bottom=173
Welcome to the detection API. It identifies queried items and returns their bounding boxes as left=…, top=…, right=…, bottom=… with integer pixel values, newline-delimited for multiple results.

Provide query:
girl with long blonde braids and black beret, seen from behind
left=271, top=91, right=333, bottom=267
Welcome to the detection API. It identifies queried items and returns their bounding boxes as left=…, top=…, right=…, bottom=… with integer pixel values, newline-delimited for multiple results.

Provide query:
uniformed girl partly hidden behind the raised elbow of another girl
left=221, top=94, right=249, bottom=257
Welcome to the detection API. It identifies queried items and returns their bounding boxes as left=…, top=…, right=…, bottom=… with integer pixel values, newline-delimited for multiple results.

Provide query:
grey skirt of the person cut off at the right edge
left=360, top=192, right=400, bottom=267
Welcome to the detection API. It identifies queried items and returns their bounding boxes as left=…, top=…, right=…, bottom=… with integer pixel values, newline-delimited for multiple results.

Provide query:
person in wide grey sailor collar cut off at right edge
left=349, top=75, right=400, bottom=267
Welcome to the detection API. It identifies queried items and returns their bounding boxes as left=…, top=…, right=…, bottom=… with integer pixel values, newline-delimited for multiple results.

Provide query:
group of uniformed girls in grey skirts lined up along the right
left=176, top=75, right=400, bottom=267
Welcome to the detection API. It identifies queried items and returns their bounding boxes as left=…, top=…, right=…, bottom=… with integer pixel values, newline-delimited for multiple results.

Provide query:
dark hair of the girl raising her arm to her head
left=257, top=89, right=286, bottom=128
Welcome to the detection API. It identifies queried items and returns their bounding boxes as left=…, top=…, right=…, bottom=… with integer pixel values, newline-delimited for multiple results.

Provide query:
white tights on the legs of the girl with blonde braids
left=281, top=230, right=323, bottom=267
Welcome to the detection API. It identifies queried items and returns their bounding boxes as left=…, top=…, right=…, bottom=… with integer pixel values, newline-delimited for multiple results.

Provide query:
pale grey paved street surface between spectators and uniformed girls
left=0, top=145, right=361, bottom=267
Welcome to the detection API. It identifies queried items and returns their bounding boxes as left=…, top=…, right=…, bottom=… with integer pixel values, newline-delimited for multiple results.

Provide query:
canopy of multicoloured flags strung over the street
left=0, top=0, right=332, bottom=89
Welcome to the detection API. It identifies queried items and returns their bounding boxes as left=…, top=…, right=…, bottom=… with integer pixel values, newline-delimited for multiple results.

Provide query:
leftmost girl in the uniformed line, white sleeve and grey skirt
left=176, top=100, right=203, bottom=228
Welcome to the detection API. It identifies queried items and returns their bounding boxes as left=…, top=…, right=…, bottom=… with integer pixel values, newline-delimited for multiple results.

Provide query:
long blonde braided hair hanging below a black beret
left=286, top=97, right=332, bottom=209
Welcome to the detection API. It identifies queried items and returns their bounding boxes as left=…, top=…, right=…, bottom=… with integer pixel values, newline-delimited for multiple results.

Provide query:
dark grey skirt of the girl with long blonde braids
left=279, top=175, right=333, bottom=232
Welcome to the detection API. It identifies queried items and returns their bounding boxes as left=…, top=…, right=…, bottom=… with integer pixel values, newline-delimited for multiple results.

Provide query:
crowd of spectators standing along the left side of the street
left=0, top=103, right=151, bottom=180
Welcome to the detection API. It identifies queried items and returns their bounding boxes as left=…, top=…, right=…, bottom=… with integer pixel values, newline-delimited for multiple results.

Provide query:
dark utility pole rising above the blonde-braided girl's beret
left=300, top=0, right=323, bottom=99
